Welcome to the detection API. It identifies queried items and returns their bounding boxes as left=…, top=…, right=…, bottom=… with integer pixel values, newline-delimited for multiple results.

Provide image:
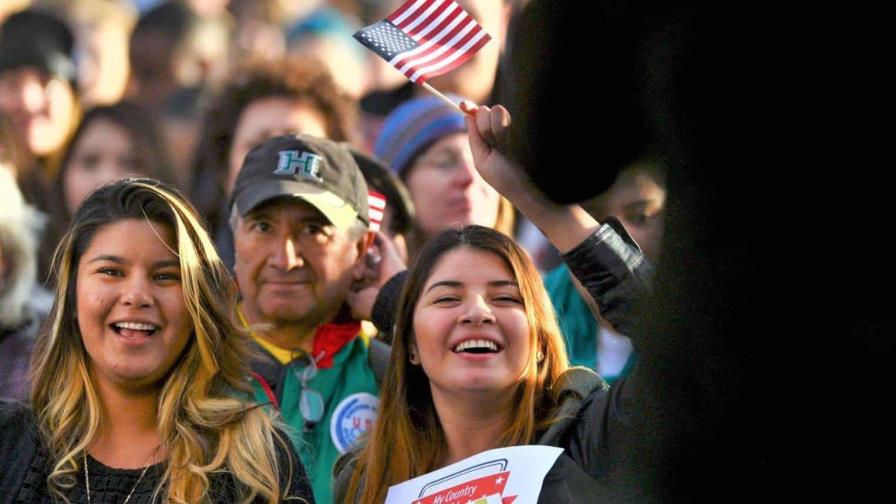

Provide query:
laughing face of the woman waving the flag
left=411, top=246, right=532, bottom=397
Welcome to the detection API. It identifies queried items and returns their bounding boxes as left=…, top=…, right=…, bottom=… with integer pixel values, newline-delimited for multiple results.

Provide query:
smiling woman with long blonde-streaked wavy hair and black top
left=0, top=179, right=313, bottom=504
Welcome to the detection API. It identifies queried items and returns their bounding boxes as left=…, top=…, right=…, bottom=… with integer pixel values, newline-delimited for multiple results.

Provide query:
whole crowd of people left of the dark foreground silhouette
left=0, top=0, right=667, bottom=503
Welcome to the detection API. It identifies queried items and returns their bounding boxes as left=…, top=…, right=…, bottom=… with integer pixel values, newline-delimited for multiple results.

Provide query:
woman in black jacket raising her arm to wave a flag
left=335, top=106, right=652, bottom=504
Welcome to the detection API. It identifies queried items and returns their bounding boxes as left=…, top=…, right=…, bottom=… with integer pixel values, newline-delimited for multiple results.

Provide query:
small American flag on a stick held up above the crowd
left=355, top=0, right=491, bottom=84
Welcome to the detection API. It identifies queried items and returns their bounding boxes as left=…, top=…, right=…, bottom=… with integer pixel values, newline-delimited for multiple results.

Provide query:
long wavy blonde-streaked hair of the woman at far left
left=31, top=179, right=300, bottom=503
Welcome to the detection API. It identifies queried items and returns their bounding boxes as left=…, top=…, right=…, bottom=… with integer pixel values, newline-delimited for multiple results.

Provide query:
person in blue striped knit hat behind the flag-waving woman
left=373, top=95, right=513, bottom=257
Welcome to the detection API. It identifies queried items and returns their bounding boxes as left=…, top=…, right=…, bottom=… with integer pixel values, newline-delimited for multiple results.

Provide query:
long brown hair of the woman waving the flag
left=346, top=226, right=568, bottom=504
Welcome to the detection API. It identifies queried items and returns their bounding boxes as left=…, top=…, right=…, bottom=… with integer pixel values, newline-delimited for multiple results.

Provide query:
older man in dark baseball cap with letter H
left=230, top=135, right=387, bottom=503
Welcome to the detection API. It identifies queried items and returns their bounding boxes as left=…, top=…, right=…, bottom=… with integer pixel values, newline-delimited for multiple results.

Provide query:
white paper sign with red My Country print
left=386, top=446, right=563, bottom=504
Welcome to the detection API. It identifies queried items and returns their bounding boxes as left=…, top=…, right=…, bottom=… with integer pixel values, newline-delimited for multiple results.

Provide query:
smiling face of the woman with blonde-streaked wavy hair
left=75, top=219, right=193, bottom=389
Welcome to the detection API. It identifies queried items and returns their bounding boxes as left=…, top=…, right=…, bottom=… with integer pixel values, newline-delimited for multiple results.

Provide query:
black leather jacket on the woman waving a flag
left=536, top=218, right=653, bottom=504
